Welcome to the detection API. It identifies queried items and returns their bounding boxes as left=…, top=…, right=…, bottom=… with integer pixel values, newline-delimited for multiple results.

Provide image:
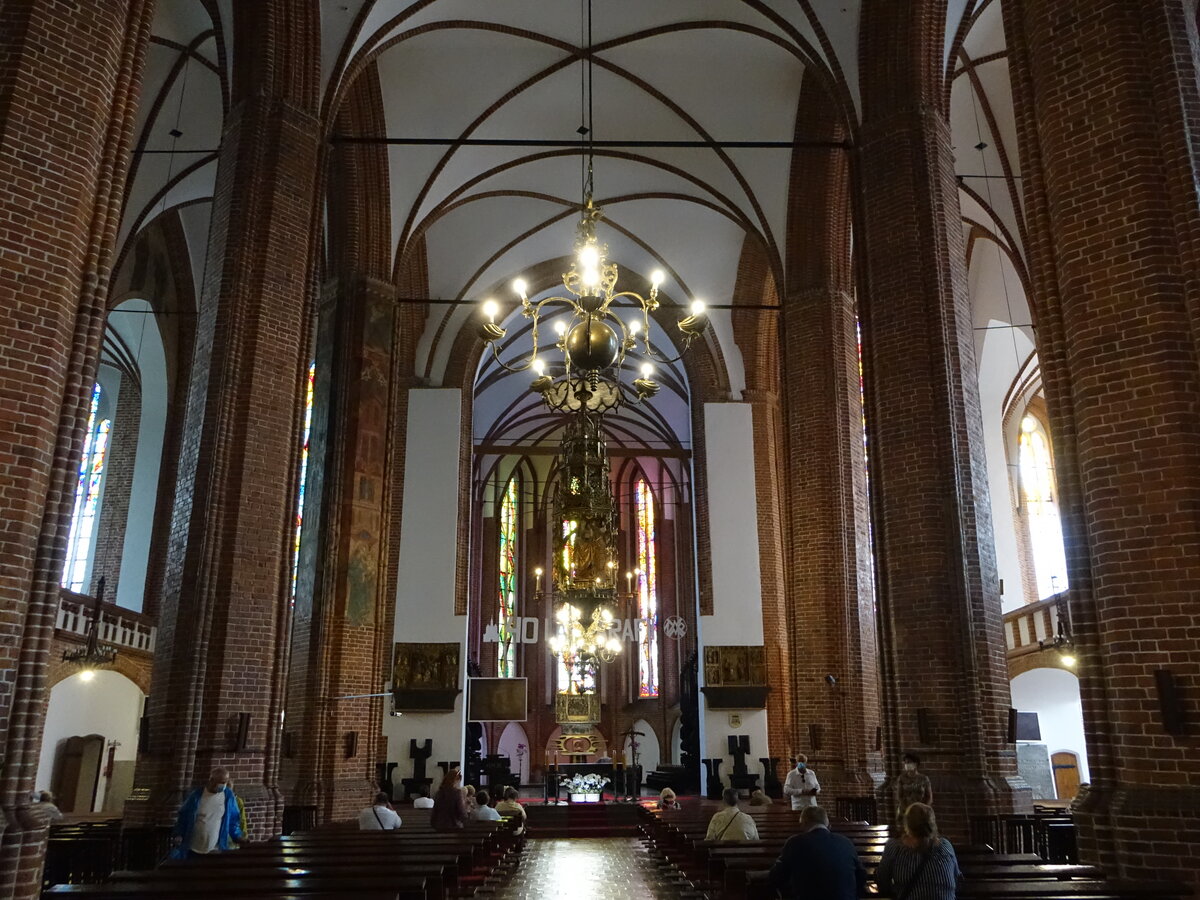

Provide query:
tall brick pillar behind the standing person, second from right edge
left=854, top=107, right=1030, bottom=839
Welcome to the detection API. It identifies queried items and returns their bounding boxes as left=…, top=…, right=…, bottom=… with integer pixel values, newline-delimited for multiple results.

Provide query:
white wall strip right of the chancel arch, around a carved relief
left=698, top=403, right=767, bottom=784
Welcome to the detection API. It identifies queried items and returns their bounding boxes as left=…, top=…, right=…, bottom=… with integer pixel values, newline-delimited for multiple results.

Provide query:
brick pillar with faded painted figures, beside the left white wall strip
left=284, top=276, right=395, bottom=821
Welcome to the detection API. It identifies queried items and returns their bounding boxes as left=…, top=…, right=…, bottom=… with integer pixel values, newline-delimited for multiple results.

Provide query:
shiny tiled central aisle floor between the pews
left=490, top=838, right=696, bottom=900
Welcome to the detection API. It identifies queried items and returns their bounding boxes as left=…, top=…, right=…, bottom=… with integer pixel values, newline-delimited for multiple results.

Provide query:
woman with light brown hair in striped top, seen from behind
left=875, top=803, right=962, bottom=900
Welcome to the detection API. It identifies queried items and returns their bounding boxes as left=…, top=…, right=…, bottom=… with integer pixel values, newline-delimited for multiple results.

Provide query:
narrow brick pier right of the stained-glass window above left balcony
left=91, top=376, right=142, bottom=604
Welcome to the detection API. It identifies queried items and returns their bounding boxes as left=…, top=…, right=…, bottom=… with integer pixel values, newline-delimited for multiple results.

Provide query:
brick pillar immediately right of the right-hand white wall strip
left=782, top=288, right=881, bottom=796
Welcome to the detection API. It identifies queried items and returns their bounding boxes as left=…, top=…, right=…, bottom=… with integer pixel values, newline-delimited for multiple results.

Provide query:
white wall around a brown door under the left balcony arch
left=36, top=670, right=145, bottom=810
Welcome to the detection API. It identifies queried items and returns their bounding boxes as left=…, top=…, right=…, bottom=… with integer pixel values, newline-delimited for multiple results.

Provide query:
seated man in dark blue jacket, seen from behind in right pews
left=770, top=806, right=866, bottom=900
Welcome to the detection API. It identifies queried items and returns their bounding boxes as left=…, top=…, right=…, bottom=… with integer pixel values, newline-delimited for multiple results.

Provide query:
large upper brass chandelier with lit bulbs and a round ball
left=480, top=194, right=708, bottom=413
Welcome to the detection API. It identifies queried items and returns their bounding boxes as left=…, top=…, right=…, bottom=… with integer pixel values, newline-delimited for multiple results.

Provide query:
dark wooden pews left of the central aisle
left=43, top=810, right=523, bottom=900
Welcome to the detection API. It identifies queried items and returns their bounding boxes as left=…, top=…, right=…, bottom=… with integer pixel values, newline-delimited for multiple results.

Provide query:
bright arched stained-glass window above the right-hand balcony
left=1018, top=415, right=1067, bottom=600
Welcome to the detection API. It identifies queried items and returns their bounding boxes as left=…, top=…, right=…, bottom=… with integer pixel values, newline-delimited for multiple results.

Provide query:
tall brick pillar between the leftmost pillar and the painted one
left=126, top=86, right=320, bottom=836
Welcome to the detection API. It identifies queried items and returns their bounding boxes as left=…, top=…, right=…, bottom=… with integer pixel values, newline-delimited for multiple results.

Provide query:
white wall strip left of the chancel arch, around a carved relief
left=383, top=388, right=467, bottom=787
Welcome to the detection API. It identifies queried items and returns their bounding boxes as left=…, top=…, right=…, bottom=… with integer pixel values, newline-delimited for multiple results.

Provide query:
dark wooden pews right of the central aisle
left=642, top=798, right=1189, bottom=900
